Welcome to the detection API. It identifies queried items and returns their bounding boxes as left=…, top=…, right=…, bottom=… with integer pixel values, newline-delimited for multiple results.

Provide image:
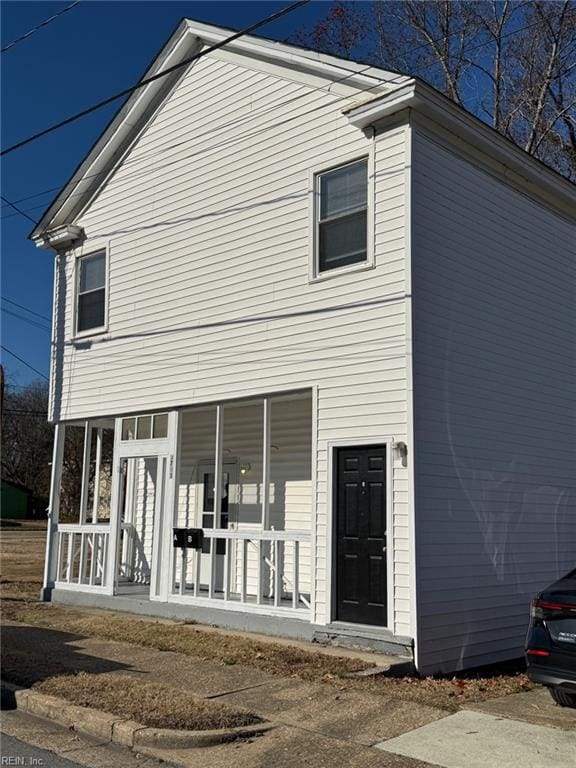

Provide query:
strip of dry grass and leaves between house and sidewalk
left=3, top=601, right=533, bottom=712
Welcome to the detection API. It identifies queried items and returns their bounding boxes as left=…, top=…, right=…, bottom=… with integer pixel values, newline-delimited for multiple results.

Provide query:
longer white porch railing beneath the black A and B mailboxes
left=171, top=528, right=311, bottom=618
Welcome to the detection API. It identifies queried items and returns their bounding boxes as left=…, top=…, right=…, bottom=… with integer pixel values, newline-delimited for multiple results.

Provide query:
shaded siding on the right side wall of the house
left=412, top=127, right=576, bottom=672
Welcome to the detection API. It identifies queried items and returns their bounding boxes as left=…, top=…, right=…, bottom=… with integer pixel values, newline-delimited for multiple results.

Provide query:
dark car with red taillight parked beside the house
left=526, top=570, right=576, bottom=707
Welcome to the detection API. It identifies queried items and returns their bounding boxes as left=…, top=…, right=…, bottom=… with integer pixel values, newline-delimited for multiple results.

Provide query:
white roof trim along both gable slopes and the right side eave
left=29, top=18, right=576, bottom=248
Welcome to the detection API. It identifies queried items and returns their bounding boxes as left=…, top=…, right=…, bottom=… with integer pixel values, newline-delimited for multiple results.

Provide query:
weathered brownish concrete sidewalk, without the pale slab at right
left=3, top=624, right=446, bottom=768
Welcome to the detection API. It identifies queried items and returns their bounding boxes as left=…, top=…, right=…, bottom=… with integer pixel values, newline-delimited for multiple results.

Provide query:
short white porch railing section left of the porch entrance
left=56, top=523, right=110, bottom=591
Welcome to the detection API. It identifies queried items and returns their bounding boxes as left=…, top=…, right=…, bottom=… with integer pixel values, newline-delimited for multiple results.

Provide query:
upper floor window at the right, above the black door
left=316, top=158, right=368, bottom=273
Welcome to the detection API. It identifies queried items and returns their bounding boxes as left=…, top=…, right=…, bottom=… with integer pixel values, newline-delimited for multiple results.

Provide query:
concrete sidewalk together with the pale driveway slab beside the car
left=2, top=623, right=576, bottom=768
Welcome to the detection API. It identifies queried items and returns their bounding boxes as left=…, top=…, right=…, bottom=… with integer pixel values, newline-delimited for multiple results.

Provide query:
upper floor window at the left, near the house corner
left=76, top=251, right=106, bottom=333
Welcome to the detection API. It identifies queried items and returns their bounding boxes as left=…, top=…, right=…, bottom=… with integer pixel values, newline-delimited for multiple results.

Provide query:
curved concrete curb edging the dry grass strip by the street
left=3, top=684, right=274, bottom=749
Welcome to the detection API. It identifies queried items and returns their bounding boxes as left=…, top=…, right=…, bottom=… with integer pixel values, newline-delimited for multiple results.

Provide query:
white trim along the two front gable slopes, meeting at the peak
left=29, top=19, right=410, bottom=247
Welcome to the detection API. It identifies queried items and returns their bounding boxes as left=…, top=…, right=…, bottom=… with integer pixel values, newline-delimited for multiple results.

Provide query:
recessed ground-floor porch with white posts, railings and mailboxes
left=44, top=391, right=313, bottom=621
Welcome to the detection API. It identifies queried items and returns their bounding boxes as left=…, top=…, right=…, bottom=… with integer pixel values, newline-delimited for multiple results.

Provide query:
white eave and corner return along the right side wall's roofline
left=345, top=80, right=576, bottom=218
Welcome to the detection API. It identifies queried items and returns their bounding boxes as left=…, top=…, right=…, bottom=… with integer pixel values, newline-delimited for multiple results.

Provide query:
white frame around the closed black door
left=326, top=436, right=394, bottom=633
